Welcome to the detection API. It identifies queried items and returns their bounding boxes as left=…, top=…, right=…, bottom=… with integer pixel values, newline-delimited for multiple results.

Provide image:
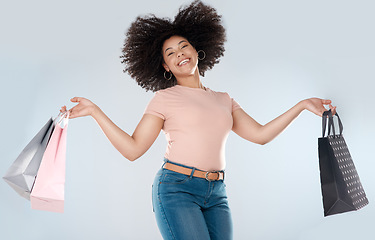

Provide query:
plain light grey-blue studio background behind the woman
left=0, top=0, right=375, bottom=240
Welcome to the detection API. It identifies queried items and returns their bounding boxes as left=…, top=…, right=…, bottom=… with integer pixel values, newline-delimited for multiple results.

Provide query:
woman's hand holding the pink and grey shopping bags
left=60, top=97, right=98, bottom=118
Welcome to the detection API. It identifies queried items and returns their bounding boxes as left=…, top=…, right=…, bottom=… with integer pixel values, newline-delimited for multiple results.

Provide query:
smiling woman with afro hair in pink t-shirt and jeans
left=61, top=1, right=335, bottom=240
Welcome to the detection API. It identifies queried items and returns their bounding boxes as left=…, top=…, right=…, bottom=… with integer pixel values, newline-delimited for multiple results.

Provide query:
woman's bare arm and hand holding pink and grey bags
left=61, top=97, right=164, bottom=161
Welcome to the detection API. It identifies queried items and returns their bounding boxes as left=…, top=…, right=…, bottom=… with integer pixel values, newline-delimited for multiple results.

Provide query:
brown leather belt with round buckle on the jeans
left=163, top=162, right=224, bottom=182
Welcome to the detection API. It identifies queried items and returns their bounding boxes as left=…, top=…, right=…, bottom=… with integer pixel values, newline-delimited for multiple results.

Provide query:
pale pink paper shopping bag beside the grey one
left=30, top=115, right=69, bottom=213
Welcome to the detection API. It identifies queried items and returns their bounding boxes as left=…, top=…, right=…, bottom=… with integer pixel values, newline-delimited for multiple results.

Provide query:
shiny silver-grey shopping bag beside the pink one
left=3, top=118, right=55, bottom=200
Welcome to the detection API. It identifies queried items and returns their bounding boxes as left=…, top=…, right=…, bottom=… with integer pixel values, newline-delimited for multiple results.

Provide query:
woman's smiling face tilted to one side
left=162, top=36, right=198, bottom=79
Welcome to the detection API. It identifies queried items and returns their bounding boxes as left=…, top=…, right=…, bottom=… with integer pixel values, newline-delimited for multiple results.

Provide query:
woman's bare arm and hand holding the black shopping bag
left=232, top=98, right=336, bottom=145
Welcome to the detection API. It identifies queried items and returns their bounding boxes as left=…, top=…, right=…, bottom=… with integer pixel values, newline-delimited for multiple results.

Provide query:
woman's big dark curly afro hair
left=120, top=0, right=226, bottom=92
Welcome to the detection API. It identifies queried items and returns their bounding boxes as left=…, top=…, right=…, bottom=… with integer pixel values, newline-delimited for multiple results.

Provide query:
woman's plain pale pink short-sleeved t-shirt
left=144, top=85, right=241, bottom=171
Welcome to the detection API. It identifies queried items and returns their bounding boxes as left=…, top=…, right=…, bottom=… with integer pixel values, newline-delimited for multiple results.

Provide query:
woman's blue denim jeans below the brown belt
left=152, top=160, right=233, bottom=240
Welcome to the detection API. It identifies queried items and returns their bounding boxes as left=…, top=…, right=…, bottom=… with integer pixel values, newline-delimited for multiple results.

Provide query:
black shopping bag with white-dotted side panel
left=318, top=110, right=368, bottom=216
